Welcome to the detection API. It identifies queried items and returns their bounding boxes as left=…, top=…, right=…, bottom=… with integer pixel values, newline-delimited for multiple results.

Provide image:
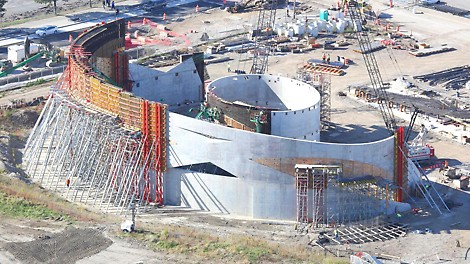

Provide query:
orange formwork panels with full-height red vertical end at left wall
left=57, top=25, right=167, bottom=204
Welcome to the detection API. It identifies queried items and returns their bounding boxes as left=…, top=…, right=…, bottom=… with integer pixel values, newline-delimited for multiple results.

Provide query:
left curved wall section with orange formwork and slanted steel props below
left=24, top=21, right=167, bottom=208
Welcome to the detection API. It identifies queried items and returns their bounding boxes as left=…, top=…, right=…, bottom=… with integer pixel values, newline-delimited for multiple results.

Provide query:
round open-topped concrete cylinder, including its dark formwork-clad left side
left=207, top=75, right=320, bottom=141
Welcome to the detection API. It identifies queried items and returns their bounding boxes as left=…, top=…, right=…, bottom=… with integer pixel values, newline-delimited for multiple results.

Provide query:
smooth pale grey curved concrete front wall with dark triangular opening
left=164, top=113, right=394, bottom=220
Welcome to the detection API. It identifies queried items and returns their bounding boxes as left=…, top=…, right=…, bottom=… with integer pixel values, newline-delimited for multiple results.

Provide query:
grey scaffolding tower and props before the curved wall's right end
left=295, top=164, right=398, bottom=232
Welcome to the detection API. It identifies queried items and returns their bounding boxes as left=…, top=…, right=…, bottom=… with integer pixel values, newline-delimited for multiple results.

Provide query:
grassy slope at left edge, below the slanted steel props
left=0, top=175, right=104, bottom=222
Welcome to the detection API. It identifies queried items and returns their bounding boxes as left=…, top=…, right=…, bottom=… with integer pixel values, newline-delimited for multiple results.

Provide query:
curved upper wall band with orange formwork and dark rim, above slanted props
left=64, top=21, right=167, bottom=172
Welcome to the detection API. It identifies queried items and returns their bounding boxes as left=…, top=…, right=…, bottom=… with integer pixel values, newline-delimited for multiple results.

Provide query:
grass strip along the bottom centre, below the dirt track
left=119, top=225, right=348, bottom=264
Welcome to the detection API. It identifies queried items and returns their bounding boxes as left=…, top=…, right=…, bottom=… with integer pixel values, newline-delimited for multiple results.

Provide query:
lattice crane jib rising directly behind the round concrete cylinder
left=250, top=0, right=278, bottom=74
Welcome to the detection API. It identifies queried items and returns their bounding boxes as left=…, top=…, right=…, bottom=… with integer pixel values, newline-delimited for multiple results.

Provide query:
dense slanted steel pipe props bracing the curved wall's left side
left=24, top=92, right=161, bottom=213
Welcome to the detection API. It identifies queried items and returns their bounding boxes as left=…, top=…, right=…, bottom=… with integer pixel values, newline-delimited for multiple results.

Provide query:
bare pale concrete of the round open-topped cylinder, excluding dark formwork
left=208, top=74, right=320, bottom=141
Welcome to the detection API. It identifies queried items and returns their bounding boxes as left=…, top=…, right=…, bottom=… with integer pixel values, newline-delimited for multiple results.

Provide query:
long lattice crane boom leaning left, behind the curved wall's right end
left=343, top=0, right=397, bottom=134
